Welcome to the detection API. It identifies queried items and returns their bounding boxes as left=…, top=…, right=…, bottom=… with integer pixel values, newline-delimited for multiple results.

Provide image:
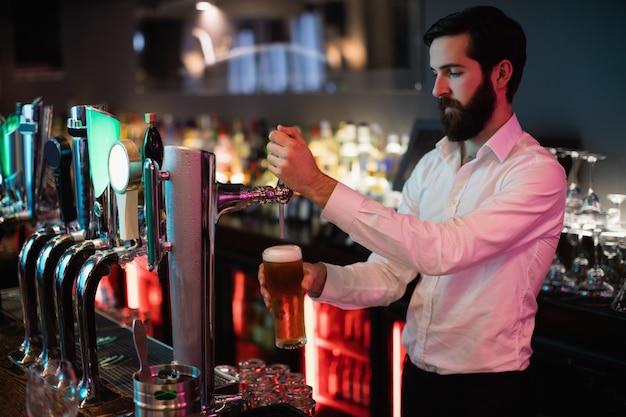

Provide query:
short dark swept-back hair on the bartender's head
left=424, top=6, right=526, bottom=102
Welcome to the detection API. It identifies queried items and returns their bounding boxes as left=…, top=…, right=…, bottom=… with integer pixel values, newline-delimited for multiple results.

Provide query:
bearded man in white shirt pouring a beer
left=259, top=6, right=566, bottom=417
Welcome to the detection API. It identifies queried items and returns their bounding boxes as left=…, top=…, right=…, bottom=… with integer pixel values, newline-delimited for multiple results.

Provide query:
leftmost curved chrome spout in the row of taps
left=9, top=228, right=58, bottom=366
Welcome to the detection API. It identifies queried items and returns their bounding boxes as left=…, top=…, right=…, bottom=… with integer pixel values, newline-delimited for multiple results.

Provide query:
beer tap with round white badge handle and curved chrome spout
left=76, top=139, right=146, bottom=408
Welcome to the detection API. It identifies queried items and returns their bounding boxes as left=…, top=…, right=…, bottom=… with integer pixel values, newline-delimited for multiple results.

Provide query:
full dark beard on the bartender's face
left=439, top=77, right=496, bottom=142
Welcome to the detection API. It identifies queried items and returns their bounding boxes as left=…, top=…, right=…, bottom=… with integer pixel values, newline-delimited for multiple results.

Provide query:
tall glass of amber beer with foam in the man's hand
left=263, top=245, right=306, bottom=349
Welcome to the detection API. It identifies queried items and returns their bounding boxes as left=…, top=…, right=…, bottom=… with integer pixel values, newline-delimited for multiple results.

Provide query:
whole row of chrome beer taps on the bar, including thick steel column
left=0, top=98, right=292, bottom=414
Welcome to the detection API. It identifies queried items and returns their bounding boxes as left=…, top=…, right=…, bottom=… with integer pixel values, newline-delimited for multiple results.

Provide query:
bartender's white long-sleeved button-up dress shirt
left=317, top=115, right=566, bottom=374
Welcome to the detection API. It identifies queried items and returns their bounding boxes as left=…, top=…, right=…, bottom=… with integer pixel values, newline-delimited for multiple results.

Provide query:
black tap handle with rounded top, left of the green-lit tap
left=44, top=136, right=77, bottom=231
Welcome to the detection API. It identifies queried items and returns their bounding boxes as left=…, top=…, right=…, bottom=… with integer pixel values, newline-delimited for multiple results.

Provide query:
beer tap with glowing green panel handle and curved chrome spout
left=42, top=106, right=120, bottom=406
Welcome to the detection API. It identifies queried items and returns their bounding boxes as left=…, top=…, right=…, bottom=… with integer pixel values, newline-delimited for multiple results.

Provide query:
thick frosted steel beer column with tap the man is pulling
left=144, top=146, right=292, bottom=411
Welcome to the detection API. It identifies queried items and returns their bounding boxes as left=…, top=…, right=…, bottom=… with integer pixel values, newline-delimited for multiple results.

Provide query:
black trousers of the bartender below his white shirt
left=402, top=356, right=534, bottom=417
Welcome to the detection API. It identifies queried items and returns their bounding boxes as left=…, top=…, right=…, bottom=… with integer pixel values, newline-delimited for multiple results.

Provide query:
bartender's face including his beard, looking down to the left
left=430, top=34, right=496, bottom=141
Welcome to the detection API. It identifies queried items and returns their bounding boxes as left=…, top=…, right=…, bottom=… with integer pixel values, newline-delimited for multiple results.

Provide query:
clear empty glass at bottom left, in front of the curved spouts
left=26, top=359, right=78, bottom=417
